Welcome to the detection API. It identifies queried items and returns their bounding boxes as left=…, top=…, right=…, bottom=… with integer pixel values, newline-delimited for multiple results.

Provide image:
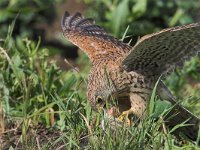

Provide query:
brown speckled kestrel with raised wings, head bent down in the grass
left=61, top=12, right=200, bottom=140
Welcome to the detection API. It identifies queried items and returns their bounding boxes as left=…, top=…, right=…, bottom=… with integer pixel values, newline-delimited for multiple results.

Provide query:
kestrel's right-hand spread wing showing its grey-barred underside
left=122, top=22, right=200, bottom=76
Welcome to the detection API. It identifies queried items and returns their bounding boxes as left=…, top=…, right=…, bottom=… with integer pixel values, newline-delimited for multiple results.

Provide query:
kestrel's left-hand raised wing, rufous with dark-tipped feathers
left=61, top=12, right=130, bottom=59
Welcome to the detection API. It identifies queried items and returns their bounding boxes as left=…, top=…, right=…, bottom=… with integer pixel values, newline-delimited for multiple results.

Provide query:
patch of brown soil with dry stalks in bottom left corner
left=0, top=123, right=67, bottom=150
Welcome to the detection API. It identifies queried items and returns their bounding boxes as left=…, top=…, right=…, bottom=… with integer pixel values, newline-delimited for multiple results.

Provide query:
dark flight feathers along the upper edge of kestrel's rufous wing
left=61, top=12, right=131, bottom=52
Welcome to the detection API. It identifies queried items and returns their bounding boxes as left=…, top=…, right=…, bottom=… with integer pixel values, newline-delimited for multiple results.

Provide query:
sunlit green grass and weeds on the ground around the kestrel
left=0, top=26, right=200, bottom=150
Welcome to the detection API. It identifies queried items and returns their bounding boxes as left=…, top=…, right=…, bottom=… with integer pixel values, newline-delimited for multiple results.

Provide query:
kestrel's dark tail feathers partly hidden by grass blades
left=157, top=81, right=200, bottom=141
